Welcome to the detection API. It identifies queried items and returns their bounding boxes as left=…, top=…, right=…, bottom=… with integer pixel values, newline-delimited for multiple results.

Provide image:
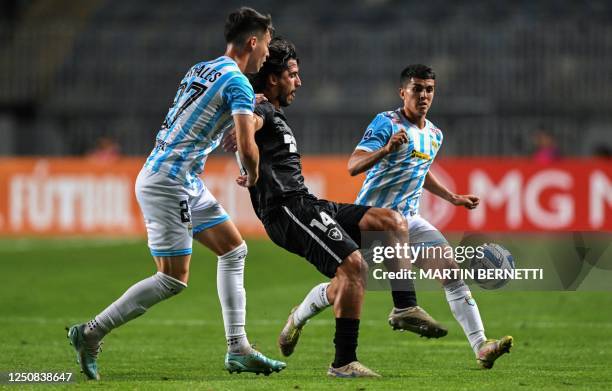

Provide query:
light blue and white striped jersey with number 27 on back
left=145, top=56, right=255, bottom=185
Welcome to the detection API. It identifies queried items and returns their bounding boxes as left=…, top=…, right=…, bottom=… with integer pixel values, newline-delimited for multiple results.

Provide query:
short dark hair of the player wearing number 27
left=225, top=7, right=274, bottom=45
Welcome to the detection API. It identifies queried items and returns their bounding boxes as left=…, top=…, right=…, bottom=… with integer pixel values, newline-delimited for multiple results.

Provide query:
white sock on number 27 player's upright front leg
left=217, top=242, right=251, bottom=353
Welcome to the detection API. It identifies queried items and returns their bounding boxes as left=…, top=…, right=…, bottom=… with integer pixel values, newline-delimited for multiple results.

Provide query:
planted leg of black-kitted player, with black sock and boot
left=327, top=251, right=380, bottom=378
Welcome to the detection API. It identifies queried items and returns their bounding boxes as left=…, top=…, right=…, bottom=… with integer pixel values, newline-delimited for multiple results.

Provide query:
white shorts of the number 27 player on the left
left=136, top=168, right=229, bottom=257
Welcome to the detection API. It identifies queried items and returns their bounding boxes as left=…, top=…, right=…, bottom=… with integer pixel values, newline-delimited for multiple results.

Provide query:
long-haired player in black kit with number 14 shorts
left=224, top=38, right=436, bottom=377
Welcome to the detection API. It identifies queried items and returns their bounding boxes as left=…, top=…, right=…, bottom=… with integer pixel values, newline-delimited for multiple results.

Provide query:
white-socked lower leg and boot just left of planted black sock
left=278, top=282, right=331, bottom=357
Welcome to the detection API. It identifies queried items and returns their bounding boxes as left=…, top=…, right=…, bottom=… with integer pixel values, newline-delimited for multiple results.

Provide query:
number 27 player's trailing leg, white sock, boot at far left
left=68, top=270, right=189, bottom=380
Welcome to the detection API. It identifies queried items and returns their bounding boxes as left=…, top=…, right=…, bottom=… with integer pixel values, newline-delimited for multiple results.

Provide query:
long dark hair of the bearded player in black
left=249, top=37, right=300, bottom=93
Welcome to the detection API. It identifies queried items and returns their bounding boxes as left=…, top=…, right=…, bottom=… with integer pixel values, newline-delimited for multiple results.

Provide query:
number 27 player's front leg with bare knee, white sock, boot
left=195, top=224, right=287, bottom=376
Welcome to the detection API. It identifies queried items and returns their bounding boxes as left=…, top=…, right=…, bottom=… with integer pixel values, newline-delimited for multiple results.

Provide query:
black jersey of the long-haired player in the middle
left=249, top=102, right=309, bottom=218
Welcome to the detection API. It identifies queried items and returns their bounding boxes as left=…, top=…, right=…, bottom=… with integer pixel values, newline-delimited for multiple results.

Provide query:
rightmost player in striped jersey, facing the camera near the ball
left=348, top=64, right=512, bottom=368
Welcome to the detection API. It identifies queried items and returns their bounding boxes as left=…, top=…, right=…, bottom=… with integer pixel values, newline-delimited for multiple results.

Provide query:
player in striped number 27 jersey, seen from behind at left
left=68, top=7, right=285, bottom=380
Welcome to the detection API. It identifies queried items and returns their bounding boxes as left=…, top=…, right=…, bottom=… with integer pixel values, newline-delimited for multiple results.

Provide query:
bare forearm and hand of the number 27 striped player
left=233, top=114, right=259, bottom=187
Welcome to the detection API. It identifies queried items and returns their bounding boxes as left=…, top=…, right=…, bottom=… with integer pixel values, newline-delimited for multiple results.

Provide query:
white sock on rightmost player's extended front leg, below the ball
left=444, top=280, right=487, bottom=354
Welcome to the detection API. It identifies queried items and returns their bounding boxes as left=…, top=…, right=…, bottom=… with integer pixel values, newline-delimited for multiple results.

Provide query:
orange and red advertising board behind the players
left=0, top=156, right=612, bottom=236
